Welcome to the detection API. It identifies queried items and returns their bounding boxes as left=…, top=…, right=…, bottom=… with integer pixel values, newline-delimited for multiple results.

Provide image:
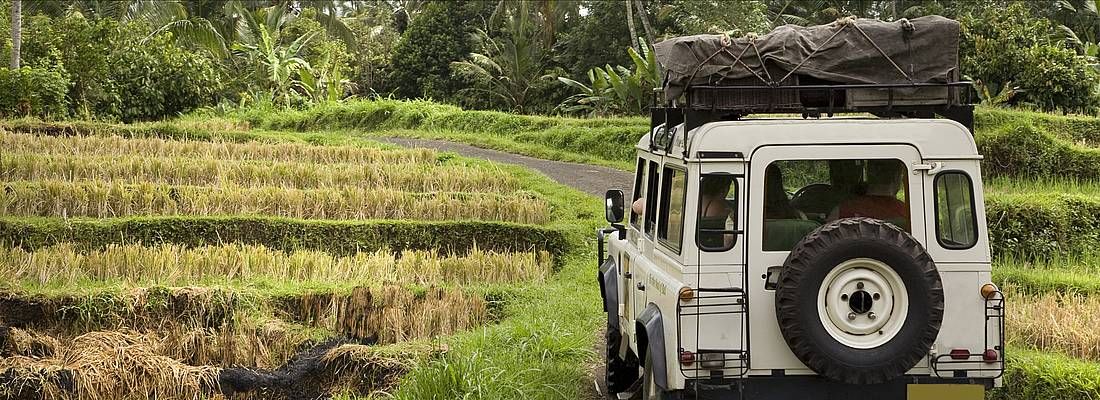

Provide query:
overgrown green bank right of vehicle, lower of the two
left=986, top=193, right=1100, bottom=258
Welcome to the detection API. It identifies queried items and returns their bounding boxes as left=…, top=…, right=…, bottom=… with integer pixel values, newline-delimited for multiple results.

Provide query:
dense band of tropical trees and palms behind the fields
left=0, top=0, right=1100, bottom=121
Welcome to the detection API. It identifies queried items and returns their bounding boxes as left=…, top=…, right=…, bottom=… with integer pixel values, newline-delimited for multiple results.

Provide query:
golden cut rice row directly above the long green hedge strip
left=0, top=180, right=550, bottom=224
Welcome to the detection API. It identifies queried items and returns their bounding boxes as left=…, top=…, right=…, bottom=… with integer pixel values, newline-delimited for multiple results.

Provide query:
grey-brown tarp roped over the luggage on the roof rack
left=653, top=15, right=959, bottom=100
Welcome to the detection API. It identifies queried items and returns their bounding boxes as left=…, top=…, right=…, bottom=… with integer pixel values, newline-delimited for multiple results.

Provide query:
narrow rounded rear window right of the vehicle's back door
left=934, top=171, right=978, bottom=249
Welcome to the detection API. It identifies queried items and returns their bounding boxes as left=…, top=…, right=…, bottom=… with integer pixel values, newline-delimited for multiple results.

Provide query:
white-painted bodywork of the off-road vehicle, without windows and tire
left=608, top=119, right=1002, bottom=389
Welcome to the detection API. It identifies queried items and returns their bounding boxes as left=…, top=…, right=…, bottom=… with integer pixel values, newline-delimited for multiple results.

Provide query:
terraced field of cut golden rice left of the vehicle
left=0, top=123, right=594, bottom=399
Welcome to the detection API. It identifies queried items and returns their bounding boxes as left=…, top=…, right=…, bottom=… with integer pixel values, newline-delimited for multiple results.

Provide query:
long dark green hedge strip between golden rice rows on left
left=0, top=216, right=570, bottom=258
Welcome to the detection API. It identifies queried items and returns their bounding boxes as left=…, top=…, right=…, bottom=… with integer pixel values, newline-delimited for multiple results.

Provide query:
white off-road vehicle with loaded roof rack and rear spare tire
left=598, top=19, right=1004, bottom=400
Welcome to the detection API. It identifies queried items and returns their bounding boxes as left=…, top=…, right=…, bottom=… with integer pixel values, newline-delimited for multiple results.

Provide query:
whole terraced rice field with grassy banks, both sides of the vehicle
left=0, top=101, right=1100, bottom=400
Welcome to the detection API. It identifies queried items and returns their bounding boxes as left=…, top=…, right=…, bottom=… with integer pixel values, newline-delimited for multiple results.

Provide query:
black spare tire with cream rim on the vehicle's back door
left=776, top=218, right=944, bottom=385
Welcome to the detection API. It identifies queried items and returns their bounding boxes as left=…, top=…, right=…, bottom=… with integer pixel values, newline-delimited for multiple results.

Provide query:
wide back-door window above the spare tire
left=757, top=159, right=912, bottom=252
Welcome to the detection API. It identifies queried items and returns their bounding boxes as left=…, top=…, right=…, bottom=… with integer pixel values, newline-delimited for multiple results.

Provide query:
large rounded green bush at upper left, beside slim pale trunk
left=23, top=13, right=220, bottom=122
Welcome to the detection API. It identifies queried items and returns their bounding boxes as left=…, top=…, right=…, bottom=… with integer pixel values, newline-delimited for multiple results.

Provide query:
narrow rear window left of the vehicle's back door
left=695, top=174, right=738, bottom=252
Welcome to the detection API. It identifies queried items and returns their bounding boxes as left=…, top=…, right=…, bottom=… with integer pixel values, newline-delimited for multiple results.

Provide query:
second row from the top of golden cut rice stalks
left=0, top=154, right=519, bottom=193
